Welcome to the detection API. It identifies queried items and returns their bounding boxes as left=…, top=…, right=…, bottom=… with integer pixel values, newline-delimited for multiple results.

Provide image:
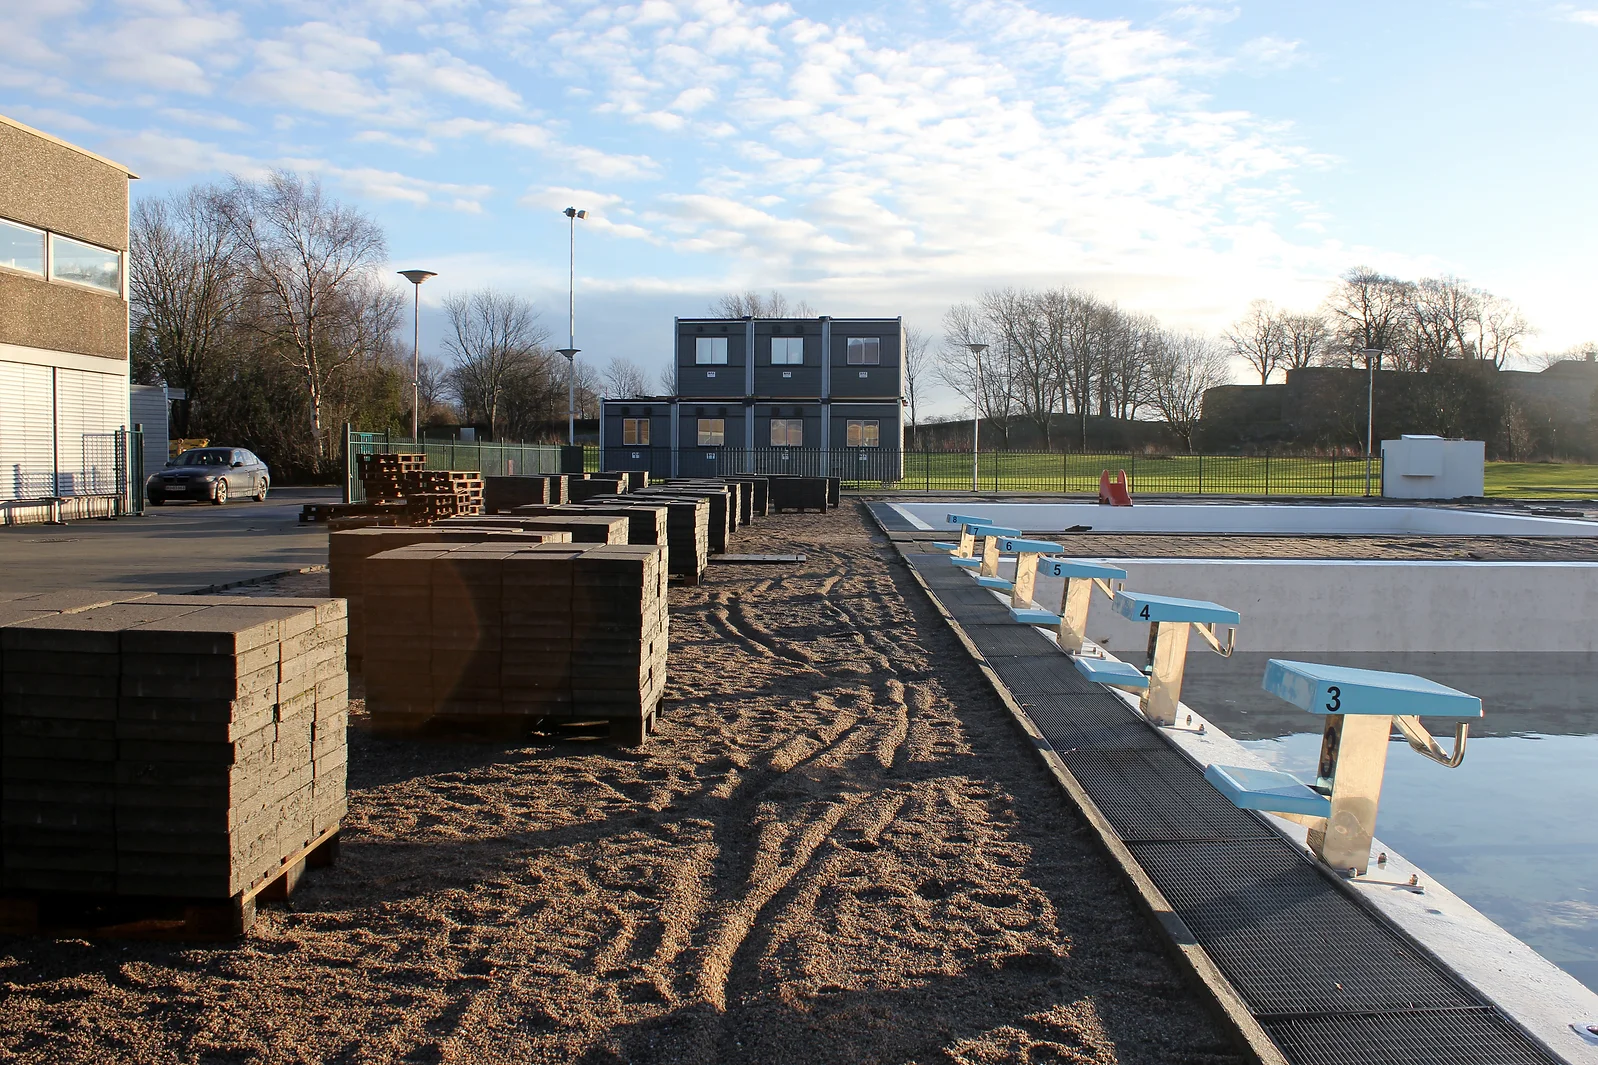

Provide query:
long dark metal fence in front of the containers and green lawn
left=583, top=448, right=1382, bottom=496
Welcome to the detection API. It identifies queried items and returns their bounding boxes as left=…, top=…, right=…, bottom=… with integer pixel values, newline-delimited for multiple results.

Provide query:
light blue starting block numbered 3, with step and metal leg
left=1203, top=659, right=1481, bottom=875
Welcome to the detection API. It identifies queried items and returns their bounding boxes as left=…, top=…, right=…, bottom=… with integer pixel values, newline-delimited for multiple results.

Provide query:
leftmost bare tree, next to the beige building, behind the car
left=128, top=185, right=244, bottom=437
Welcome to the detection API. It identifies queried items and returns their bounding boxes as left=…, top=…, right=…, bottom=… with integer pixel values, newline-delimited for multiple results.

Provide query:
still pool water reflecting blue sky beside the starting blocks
left=1183, top=652, right=1598, bottom=991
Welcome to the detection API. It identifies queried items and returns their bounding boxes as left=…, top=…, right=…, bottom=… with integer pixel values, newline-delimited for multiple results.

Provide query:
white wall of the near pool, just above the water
left=1000, top=558, right=1598, bottom=657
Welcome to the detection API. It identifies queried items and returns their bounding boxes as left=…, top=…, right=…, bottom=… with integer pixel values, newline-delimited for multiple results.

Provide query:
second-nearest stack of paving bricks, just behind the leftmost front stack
left=366, top=544, right=666, bottom=744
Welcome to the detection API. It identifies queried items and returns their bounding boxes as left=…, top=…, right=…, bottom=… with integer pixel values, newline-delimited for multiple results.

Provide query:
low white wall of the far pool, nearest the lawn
left=890, top=499, right=1598, bottom=536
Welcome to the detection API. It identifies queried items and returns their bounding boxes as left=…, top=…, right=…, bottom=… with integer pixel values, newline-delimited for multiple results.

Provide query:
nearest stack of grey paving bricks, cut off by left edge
left=0, top=595, right=348, bottom=900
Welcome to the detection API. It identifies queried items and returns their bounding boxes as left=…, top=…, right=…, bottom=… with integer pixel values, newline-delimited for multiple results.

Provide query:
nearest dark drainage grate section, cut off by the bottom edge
left=1262, top=1007, right=1558, bottom=1065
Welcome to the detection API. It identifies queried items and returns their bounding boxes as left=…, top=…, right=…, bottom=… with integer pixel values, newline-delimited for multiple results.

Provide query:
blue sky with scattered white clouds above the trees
left=0, top=0, right=1598, bottom=413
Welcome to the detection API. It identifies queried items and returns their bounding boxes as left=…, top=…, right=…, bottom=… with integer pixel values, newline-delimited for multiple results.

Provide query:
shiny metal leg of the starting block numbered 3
left=1307, top=713, right=1393, bottom=876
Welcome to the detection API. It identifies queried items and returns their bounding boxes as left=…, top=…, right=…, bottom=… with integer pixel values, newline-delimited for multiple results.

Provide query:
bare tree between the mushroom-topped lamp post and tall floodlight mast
left=444, top=288, right=550, bottom=433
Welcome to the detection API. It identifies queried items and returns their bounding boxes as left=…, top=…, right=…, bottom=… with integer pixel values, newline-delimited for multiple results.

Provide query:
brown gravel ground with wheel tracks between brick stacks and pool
left=0, top=505, right=1238, bottom=1065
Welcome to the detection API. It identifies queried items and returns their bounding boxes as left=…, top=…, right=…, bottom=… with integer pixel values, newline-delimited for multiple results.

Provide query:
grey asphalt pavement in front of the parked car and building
left=0, top=488, right=340, bottom=592
